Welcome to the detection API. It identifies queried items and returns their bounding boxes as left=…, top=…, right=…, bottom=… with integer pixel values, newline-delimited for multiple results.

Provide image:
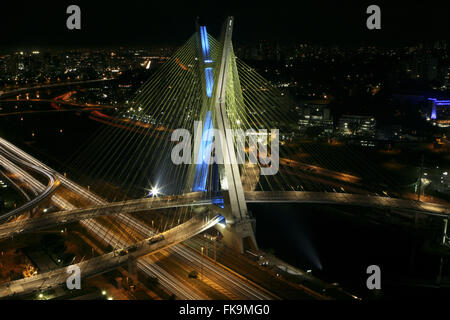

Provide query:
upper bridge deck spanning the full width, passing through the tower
left=0, top=191, right=450, bottom=239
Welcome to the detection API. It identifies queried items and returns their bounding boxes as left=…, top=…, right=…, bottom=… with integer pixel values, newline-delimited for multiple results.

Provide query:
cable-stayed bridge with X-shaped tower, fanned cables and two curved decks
left=0, top=17, right=449, bottom=295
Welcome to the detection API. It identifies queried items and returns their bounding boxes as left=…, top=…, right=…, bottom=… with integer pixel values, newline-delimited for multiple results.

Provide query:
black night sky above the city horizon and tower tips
left=0, top=0, right=450, bottom=48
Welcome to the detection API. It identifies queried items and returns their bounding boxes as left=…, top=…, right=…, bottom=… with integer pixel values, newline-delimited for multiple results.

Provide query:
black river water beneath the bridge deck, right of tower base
left=249, top=204, right=450, bottom=298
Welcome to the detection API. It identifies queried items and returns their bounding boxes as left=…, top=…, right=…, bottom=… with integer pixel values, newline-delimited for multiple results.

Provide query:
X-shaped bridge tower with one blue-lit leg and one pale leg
left=188, top=17, right=257, bottom=252
